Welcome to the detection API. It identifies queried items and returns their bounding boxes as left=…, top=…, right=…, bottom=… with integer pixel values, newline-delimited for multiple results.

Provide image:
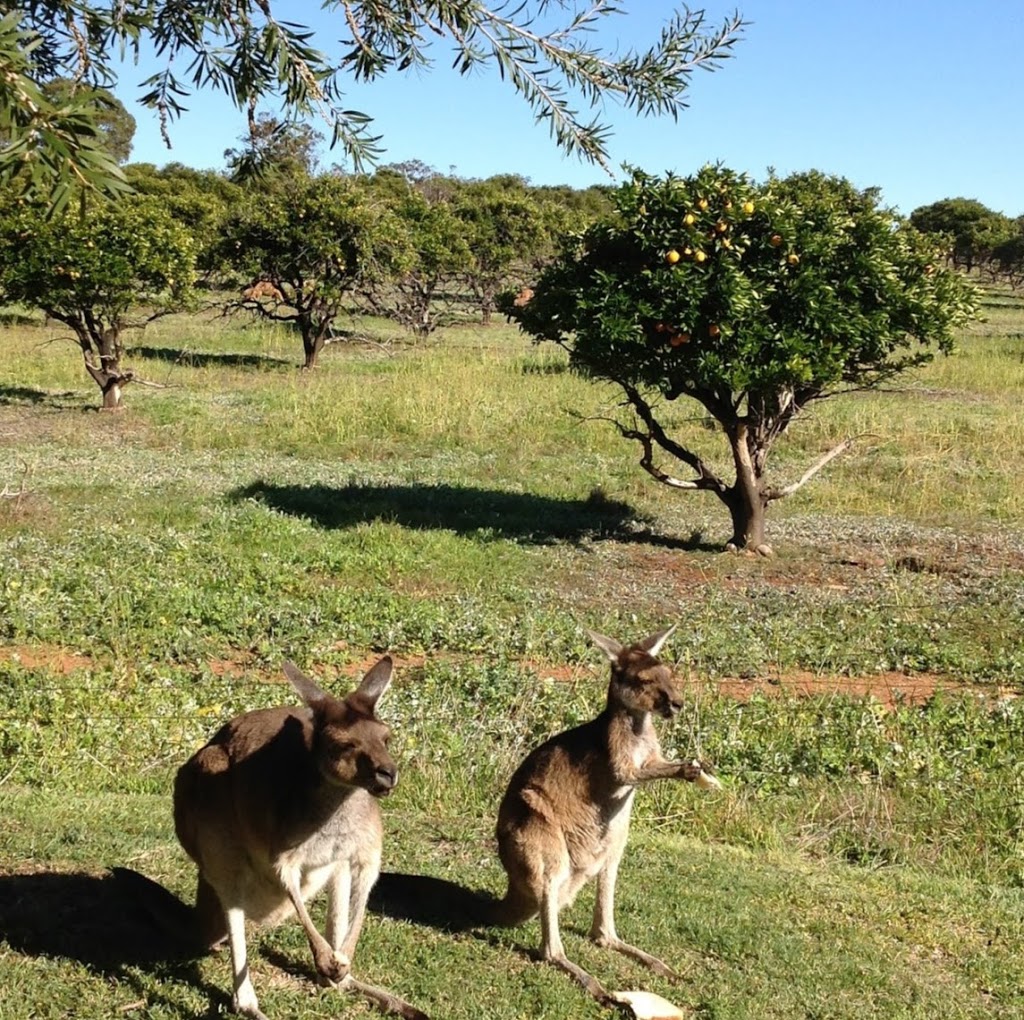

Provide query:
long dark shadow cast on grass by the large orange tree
left=228, top=481, right=638, bottom=545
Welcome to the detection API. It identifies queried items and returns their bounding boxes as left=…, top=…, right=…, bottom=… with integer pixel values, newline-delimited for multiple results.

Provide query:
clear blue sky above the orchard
left=117, top=0, right=1024, bottom=216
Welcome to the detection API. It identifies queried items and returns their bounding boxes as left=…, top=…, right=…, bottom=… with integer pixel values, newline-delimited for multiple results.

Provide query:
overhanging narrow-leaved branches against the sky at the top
left=0, top=0, right=742, bottom=204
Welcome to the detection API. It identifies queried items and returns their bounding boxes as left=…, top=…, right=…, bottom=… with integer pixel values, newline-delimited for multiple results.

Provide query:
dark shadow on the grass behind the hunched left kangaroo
left=0, top=872, right=229, bottom=1016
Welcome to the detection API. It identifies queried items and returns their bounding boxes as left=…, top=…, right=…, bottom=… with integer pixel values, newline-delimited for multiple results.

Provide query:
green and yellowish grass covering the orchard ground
left=0, top=292, right=1024, bottom=1020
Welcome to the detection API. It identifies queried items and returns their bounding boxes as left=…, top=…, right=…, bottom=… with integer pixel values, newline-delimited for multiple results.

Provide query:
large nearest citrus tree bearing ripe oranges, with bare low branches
left=504, top=166, right=976, bottom=553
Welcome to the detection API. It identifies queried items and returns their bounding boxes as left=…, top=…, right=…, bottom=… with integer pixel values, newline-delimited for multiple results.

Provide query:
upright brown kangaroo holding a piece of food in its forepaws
left=494, top=627, right=721, bottom=1006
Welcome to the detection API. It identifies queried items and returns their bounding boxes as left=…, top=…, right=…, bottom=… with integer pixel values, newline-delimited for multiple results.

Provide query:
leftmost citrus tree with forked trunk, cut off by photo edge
left=0, top=196, right=196, bottom=410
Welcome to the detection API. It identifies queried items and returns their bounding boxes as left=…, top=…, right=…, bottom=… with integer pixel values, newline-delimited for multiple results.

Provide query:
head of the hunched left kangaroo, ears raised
left=285, top=655, right=398, bottom=797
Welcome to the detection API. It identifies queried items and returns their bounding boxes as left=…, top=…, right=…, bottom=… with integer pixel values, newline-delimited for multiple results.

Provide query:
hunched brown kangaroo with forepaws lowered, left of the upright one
left=174, top=656, right=426, bottom=1020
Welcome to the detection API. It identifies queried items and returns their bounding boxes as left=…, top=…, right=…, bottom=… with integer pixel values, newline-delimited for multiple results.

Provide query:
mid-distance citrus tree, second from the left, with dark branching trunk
left=212, top=175, right=413, bottom=369
